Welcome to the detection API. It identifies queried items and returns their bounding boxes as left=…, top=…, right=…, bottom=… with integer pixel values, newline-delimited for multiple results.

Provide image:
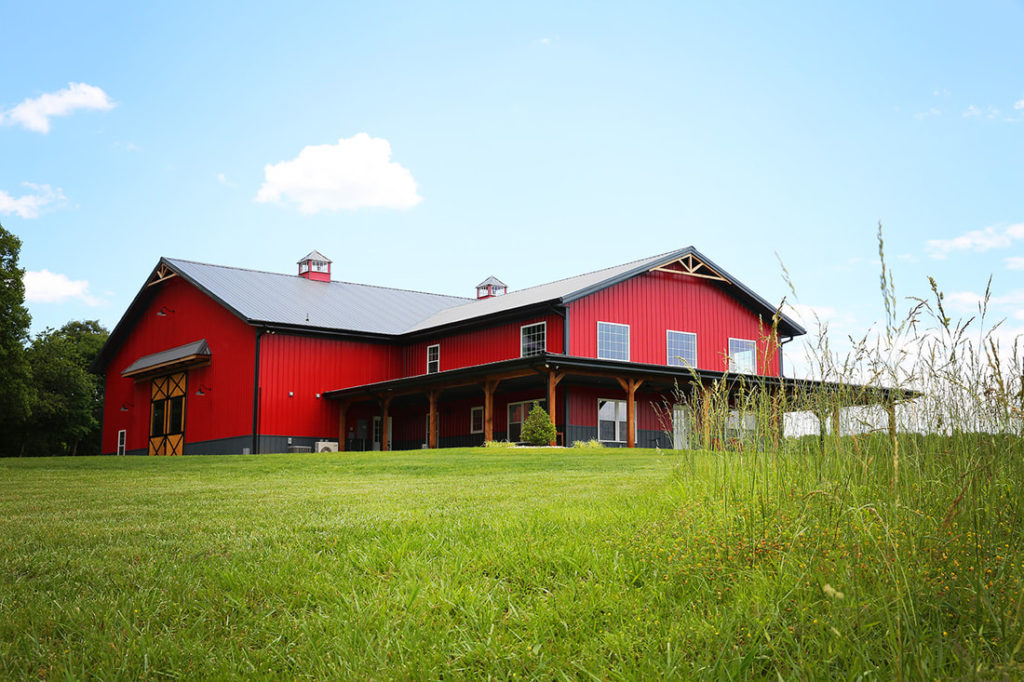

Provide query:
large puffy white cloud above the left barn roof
left=255, top=133, right=423, bottom=213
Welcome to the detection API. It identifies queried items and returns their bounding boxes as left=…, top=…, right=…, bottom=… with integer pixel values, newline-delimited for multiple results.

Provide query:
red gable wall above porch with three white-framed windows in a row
left=568, top=272, right=778, bottom=374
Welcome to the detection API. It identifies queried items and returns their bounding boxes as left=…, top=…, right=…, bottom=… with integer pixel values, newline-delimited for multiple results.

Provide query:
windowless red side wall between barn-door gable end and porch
left=259, top=334, right=399, bottom=440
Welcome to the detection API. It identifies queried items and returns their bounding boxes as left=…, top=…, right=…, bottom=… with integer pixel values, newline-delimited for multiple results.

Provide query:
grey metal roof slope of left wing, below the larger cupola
left=165, top=258, right=467, bottom=334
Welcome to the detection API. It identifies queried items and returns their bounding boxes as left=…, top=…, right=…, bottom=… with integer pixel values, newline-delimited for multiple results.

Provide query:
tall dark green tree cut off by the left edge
left=0, top=225, right=34, bottom=455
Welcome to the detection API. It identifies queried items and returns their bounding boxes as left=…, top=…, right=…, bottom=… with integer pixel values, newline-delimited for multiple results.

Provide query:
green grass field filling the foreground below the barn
left=0, top=449, right=1024, bottom=679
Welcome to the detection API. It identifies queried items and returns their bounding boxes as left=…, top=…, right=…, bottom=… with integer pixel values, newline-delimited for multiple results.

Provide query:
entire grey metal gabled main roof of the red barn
left=93, top=247, right=807, bottom=368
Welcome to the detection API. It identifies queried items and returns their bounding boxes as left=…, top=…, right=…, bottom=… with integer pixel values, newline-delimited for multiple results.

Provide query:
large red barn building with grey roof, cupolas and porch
left=97, top=247, right=805, bottom=455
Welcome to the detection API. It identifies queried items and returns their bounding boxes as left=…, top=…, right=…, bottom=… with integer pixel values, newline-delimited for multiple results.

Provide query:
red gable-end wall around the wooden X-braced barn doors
left=102, top=278, right=255, bottom=453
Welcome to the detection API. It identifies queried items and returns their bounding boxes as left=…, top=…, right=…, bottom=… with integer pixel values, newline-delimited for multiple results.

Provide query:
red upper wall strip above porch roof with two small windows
left=402, top=314, right=563, bottom=377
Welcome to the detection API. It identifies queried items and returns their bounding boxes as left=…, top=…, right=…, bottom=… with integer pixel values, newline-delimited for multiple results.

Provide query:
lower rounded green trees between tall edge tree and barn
left=24, top=319, right=108, bottom=455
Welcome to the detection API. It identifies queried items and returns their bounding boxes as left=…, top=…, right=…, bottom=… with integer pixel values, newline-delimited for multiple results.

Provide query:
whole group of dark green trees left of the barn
left=0, top=225, right=109, bottom=457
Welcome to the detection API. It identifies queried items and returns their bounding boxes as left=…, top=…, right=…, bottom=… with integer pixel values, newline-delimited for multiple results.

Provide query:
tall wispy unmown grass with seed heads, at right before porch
left=663, top=226, right=1024, bottom=678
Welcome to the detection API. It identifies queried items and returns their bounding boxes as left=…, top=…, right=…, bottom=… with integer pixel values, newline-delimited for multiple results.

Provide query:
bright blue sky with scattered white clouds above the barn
left=0, top=1, right=1024, bottom=374
